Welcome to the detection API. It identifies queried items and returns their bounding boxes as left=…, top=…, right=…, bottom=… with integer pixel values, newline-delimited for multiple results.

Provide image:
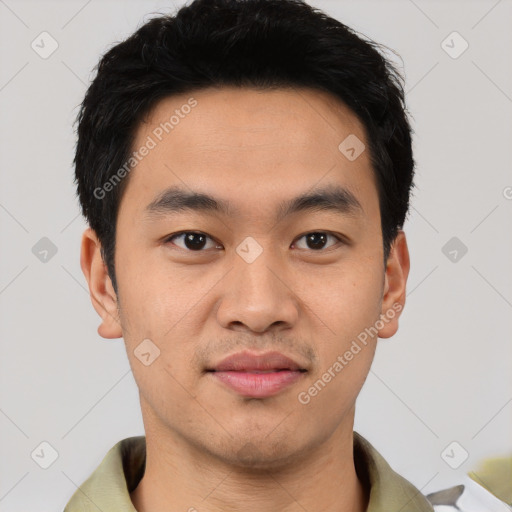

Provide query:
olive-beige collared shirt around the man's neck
left=64, top=432, right=434, bottom=512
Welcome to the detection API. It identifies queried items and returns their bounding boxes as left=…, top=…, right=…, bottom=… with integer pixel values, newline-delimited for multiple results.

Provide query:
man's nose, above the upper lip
left=217, top=250, right=299, bottom=333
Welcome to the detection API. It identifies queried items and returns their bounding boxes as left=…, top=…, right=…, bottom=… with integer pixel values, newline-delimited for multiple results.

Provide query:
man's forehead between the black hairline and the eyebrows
left=121, top=87, right=378, bottom=222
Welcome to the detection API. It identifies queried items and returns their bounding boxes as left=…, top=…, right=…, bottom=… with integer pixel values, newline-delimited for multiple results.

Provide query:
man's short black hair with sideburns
left=74, top=0, right=414, bottom=293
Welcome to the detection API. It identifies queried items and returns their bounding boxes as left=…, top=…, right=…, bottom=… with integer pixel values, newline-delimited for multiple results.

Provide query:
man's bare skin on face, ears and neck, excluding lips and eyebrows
left=81, top=88, right=409, bottom=512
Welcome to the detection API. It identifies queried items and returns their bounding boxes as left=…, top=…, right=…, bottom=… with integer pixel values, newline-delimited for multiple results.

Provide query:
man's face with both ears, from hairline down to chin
left=82, top=88, right=409, bottom=467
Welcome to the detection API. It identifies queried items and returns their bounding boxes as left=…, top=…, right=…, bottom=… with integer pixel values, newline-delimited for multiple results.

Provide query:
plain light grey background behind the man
left=0, top=0, right=512, bottom=512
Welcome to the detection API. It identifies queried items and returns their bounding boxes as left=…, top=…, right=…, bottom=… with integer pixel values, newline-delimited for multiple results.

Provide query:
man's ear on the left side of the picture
left=80, top=228, right=123, bottom=339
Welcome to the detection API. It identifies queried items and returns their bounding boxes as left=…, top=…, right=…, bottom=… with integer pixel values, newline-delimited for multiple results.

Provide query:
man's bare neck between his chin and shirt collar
left=130, top=421, right=368, bottom=512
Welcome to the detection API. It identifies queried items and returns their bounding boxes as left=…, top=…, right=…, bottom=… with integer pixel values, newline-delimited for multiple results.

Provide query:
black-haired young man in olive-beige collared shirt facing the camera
left=66, top=0, right=433, bottom=512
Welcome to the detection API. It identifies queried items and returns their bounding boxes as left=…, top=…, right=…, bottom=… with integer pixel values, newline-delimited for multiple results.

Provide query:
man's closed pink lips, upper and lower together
left=208, top=351, right=307, bottom=398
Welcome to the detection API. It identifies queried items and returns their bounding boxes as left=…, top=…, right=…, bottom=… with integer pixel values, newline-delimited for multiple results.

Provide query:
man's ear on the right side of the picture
left=378, top=230, right=410, bottom=338
